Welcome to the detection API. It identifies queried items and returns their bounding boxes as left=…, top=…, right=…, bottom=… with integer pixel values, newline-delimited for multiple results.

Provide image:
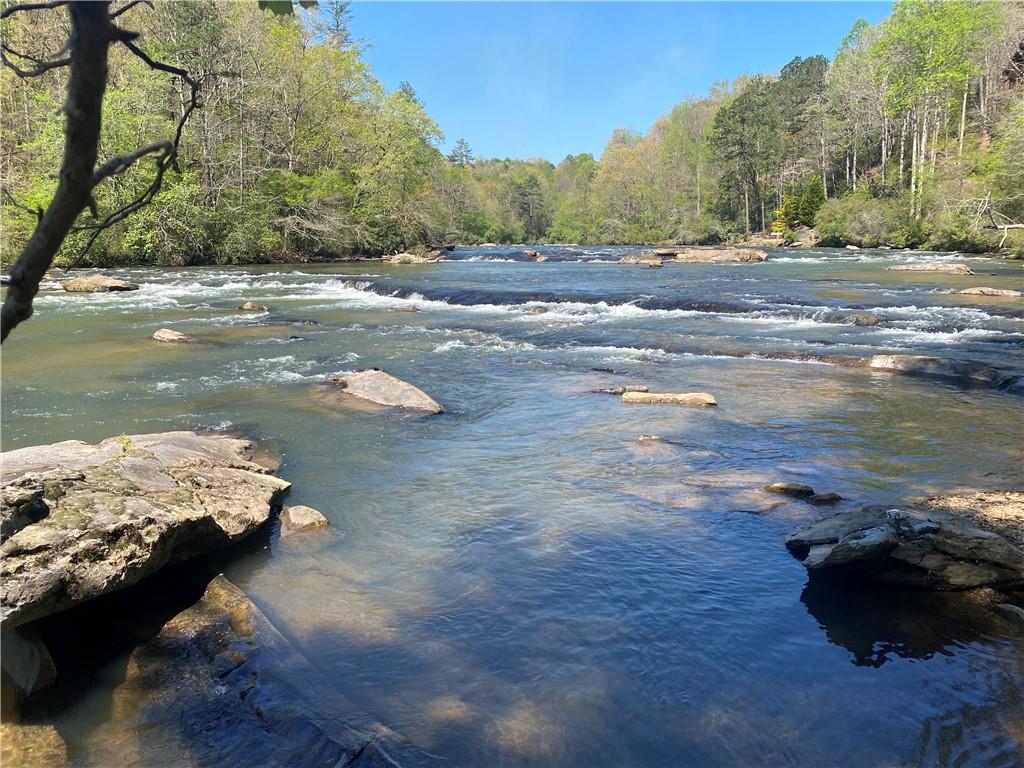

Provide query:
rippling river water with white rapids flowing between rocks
left=3, top=248, right=1024, bottom=766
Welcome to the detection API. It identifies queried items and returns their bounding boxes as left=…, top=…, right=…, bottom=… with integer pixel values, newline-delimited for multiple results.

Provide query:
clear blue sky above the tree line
left=352, top=0, right=891, bottom=163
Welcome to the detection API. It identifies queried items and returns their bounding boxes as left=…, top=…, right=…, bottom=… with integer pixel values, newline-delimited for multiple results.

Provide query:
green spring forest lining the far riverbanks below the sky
left=0, top=0, right=1024, bottom=264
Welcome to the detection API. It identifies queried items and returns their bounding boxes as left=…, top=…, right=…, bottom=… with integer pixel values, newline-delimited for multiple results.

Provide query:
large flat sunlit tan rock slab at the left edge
left=0, top=432, right=291, bottom=630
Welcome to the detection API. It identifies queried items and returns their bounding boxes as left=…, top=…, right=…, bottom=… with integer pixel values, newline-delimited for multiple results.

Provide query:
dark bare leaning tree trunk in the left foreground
left=0, top=2, right=116, bottom=341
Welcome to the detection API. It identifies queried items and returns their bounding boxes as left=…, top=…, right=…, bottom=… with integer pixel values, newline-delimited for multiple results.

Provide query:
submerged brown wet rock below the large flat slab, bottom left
left=81, top=577, right=433, bottom=768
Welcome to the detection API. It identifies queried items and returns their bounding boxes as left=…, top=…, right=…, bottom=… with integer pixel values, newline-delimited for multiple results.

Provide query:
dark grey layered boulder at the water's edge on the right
left=785, top=506, right=1024, bottom=590
